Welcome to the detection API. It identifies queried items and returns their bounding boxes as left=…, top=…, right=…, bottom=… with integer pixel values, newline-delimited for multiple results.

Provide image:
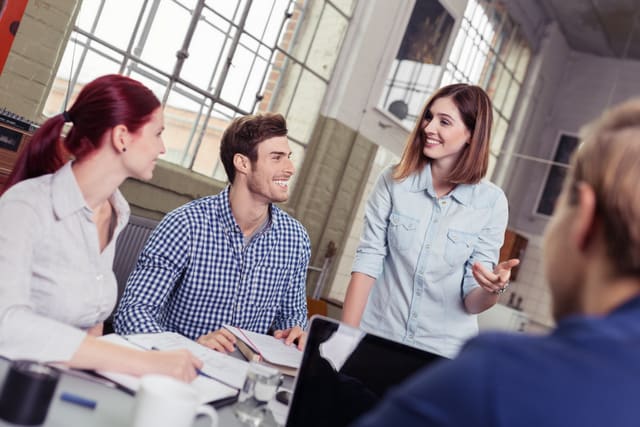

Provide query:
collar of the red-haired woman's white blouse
left=51, top=161, right=130, bottom=227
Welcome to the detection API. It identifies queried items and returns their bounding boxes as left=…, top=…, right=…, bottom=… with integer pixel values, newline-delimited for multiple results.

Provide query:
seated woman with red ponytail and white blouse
left=0, top=75, right=201, bottom=381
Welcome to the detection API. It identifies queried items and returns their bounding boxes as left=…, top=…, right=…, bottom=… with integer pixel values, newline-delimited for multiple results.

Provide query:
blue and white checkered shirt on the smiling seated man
left=114, top=187, right=311, bottom=339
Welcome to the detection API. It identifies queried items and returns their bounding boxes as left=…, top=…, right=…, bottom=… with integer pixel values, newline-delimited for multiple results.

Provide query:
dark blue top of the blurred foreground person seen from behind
left=355, top=297, right=640, bottom=427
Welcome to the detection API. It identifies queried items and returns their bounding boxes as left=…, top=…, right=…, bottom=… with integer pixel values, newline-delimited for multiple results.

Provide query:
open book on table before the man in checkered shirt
left=223, top=325, right=302, bottom=375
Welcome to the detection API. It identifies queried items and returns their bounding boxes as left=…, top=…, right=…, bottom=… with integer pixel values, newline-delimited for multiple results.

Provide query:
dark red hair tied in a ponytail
left=0, top=74, right=160, bottom=194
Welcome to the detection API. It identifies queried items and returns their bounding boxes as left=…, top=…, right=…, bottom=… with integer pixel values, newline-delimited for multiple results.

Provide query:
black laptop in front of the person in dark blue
left=286, top=316, right=443, bottom=427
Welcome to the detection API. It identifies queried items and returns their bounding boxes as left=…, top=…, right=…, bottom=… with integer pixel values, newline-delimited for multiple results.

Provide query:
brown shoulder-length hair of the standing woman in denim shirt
left=393, top=83, right=493, bottom=184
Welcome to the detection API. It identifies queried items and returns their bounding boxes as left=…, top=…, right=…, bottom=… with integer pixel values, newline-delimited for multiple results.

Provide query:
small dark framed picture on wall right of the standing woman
left=535, top=132, right=580, bottom=216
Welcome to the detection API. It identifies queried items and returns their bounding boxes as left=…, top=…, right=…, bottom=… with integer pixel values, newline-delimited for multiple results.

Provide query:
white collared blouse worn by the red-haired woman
left=0, top=162, right=129, bottom=361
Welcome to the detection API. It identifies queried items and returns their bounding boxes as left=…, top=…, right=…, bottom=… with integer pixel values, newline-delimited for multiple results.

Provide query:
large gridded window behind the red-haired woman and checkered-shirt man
left=45, top=0, right=355, bottom=186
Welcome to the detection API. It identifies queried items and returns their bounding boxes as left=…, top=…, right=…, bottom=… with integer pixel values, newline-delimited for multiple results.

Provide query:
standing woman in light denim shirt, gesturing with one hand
left=342, top=84, right=519, bottom=357
